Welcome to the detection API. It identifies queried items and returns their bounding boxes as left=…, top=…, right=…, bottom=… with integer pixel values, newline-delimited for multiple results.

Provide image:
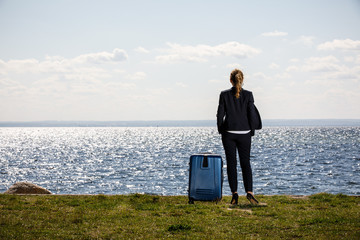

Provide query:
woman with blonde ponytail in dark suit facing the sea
left=217, top=69, right=261, bottom=204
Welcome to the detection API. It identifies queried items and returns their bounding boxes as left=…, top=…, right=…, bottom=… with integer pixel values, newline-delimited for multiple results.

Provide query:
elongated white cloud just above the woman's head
left=156, top=42, right=261, bottom=63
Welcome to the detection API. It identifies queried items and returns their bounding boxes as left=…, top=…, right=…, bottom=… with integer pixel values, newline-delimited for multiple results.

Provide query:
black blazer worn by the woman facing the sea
left=217, top=87, right=262, bottom=136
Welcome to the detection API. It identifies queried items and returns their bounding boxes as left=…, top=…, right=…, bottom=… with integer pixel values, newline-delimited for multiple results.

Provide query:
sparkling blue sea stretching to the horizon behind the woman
left=0, top=120, right=360, bottom=196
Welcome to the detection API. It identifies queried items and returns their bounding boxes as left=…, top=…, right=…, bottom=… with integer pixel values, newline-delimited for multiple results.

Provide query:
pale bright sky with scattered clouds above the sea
left=0, top=0, right=360, bottom=121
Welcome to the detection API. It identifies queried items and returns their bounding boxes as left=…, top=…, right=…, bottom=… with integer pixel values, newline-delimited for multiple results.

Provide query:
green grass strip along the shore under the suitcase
left=0, top=193, right=360, bottom=240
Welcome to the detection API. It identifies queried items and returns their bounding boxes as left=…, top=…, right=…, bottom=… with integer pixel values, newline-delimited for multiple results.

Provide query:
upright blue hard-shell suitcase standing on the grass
left=189, top=154, right=223, bottom=204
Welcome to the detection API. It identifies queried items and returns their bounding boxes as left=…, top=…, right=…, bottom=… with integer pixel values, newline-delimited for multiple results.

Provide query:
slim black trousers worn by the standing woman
left=222, top=132, right=253, bottom=193
